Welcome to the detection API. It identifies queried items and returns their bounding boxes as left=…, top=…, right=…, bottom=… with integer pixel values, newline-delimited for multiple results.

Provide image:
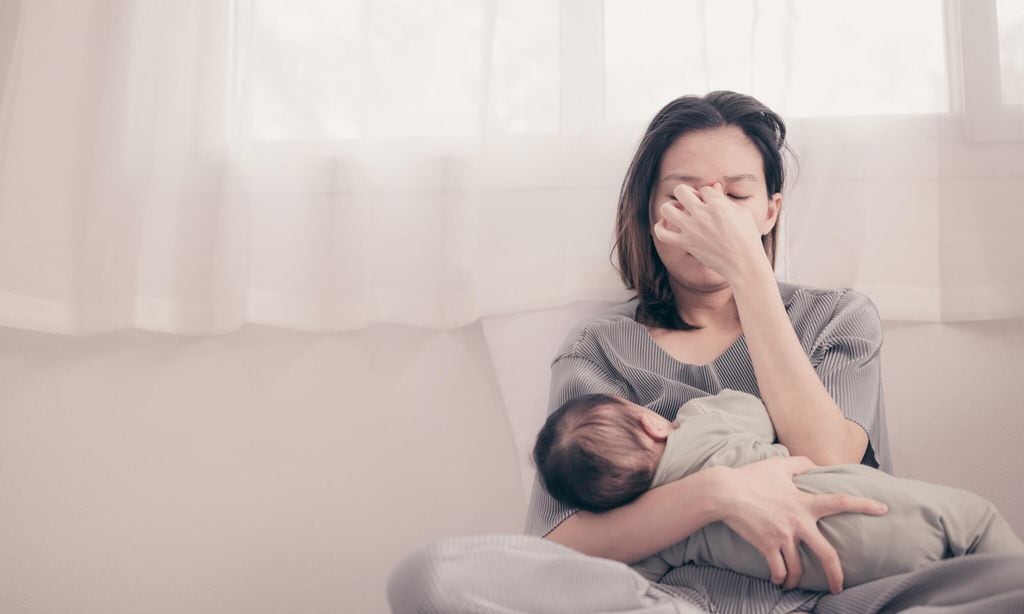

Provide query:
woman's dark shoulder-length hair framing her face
left=612, top=91, right=793, bottom=331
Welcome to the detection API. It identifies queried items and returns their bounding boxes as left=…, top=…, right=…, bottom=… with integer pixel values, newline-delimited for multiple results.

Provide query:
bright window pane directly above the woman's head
left=604, top=0, right=949, bottom=121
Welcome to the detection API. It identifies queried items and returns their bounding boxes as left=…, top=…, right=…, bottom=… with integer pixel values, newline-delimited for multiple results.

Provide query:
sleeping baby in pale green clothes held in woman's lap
left=534, top=389, right=1024, bottom=591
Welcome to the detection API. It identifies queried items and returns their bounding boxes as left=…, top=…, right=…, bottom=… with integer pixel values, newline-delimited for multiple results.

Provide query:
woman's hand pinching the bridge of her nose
left=653, top=183, right=766, bottom=280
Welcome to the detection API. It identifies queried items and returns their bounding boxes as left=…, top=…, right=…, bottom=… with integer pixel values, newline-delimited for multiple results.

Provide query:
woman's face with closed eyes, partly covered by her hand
left=649, top=126, right=782, bottom=289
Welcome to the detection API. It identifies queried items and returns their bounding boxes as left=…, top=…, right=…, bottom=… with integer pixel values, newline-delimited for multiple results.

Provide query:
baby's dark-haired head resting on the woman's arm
left=534, top=394, right=657, bottom=512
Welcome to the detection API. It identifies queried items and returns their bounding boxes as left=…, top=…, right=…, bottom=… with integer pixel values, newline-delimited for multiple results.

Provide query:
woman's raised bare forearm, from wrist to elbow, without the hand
left=729, top=259, right=867, bottom=465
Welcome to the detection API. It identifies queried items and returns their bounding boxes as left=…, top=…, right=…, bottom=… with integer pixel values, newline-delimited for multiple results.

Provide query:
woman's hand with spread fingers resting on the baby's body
left=716, top=456, right=887, bottom=593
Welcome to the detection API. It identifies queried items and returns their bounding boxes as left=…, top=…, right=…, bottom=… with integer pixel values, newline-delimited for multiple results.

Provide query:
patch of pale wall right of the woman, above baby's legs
left=882, top=319, right=1024, bottom=537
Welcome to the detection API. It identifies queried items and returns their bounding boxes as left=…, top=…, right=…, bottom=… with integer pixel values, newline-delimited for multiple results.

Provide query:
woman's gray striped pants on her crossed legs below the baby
left=387, top=535, right=1024, bottom=614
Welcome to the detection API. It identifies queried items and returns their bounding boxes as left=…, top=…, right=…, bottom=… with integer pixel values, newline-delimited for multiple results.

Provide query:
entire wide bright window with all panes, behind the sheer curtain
left=237, top=0, right=1024, bottom=140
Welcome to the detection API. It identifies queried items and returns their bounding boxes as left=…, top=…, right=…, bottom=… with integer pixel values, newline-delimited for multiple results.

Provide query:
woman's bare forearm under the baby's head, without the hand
left=546, top=468, right=724, bottom=564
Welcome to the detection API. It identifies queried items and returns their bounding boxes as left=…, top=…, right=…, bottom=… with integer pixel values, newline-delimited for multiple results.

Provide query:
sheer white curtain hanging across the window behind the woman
left=0, top=0, right=1024, bottom=334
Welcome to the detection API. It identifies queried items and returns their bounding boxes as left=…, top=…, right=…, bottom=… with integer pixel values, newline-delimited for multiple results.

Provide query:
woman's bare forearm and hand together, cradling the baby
left=546, top=456, right=886, bottom=593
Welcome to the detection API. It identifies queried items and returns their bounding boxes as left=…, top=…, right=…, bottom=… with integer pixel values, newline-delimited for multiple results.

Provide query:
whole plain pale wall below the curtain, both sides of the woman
left=0, top=320, right=1024, bottom=614
